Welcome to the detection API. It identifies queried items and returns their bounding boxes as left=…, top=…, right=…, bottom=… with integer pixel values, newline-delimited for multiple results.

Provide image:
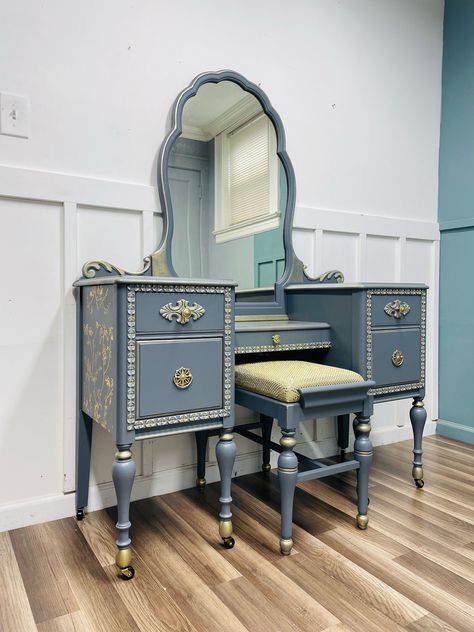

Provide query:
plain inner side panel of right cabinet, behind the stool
left=286, top=288, right=360, bottom=371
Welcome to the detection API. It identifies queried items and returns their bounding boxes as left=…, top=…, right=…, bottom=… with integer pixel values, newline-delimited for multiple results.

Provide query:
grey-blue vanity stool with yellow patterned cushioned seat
left=235, top=360, right=375, bottom=555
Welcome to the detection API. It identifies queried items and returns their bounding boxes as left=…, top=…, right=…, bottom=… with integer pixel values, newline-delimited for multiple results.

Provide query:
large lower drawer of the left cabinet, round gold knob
left=136, top=337, right=223, bottom=419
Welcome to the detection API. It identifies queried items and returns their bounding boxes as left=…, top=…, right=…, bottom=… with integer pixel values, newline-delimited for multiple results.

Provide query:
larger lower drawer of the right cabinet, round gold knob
left=372, top=327, right=421, bottom=387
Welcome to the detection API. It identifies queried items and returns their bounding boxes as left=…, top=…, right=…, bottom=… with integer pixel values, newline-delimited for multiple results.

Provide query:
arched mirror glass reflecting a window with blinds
left=168, top=81, right=287, bottom=289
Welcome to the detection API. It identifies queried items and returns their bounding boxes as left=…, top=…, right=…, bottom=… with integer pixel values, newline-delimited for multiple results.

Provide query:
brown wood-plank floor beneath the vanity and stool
left=0, top=437, right=474, bottom=632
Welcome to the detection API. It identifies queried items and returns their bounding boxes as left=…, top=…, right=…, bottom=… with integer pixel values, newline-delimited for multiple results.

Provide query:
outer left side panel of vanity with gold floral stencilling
left=81, top=285, right=117, bottom=432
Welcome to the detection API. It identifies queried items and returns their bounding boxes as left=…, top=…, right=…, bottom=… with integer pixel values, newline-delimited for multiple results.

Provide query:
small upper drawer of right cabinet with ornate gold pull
left=372, top=294, right=421, bottom=327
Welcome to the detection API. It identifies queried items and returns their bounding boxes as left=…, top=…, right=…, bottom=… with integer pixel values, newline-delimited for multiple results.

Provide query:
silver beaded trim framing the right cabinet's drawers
left=366, top=288, right=426, bottom=395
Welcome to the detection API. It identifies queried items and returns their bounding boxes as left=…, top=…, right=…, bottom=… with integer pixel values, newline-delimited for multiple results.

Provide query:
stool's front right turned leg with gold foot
left=354, top=414, right=373, bottom=529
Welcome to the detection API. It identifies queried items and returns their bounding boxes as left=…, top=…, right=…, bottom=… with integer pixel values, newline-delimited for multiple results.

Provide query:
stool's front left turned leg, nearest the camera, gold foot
left=278, top=429, right=298, bottom=555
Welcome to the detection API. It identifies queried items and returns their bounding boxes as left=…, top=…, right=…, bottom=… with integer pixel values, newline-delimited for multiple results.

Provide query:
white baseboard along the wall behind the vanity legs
left=0, top=421, right=436, bottom=532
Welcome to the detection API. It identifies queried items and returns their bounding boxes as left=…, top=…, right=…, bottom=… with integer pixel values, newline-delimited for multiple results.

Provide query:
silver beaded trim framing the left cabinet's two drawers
left=127, top=284, right=232, bottom=430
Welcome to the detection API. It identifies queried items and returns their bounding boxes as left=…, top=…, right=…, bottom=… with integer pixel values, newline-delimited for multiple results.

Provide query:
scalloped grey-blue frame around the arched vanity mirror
left=157, top=70, right=300, bottom=315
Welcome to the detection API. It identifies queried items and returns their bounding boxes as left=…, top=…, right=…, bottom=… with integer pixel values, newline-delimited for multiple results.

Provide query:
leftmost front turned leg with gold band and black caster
left=112, top=444, right=136, bottom=579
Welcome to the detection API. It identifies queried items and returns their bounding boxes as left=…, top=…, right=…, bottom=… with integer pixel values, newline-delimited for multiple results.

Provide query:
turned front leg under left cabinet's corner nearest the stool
left=216, top=428, right=237, bottom=549
